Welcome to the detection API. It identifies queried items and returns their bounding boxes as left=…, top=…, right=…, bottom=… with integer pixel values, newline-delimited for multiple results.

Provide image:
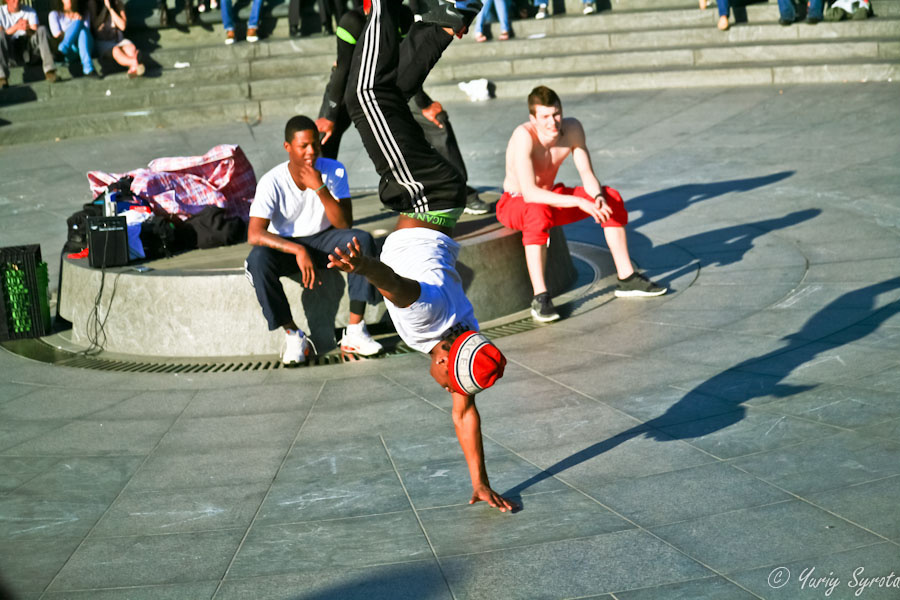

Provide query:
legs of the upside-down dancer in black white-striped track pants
left=344, top=0, right=481, bottom=222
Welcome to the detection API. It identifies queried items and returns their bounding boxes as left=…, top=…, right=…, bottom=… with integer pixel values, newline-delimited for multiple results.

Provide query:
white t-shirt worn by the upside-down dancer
left=381, top=227, right=478, bottom=353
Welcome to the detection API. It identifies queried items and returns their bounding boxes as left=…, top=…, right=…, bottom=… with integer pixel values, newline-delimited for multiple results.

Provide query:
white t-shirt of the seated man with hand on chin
left=250, top=158, right=350, bottom=238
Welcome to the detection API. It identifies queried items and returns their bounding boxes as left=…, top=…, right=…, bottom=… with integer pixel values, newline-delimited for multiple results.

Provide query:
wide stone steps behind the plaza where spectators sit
left=0, top=0, right=900, bottom=143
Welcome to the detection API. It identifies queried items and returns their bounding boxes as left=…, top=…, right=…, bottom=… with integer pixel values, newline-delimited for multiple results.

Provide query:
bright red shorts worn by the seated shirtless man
left=497, top=183, right=628, bottom=246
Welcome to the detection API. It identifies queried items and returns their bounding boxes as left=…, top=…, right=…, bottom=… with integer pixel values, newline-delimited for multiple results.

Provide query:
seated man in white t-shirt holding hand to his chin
left=245, top=116, right=381, bottom=366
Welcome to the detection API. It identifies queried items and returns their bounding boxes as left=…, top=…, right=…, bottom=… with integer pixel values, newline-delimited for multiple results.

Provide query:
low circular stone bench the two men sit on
left=59, top=196, right=576, bottom=357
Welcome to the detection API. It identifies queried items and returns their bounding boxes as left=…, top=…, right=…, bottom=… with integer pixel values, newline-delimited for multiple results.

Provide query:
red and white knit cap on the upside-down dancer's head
left=449, top=330, right=506, bottom=395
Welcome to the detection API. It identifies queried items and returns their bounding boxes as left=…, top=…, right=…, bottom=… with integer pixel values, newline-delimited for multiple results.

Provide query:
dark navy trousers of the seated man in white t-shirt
left=244, top=227, right=380, bottom=331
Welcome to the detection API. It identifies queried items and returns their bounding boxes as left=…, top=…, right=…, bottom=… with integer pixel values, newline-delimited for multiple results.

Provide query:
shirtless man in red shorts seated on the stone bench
left=497, top=86, right=667, bottom=322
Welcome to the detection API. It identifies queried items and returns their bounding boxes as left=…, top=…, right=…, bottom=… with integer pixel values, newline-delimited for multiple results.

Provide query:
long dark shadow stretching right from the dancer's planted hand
left=503, top=277, right=900, bottom=499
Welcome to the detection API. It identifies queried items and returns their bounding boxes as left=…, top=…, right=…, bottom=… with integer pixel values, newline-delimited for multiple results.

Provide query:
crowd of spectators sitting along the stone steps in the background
left=0, top=0, right=872, bottom=89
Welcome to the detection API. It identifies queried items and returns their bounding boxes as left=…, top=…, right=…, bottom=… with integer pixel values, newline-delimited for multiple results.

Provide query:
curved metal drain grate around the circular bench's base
left=0, top=317, right=546, bottom=375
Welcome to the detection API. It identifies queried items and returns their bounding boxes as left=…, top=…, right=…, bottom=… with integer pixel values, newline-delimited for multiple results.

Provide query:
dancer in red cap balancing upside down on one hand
left=328, top=0, right=518, bottom=512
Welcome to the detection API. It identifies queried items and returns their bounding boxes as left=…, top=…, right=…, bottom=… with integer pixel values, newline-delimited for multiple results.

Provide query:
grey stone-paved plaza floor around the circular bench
left=0, top=84, right=900, bottom=600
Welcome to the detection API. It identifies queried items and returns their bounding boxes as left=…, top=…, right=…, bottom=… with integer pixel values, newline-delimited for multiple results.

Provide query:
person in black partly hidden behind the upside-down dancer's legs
left=316, top=3, right=490, bottom=215
